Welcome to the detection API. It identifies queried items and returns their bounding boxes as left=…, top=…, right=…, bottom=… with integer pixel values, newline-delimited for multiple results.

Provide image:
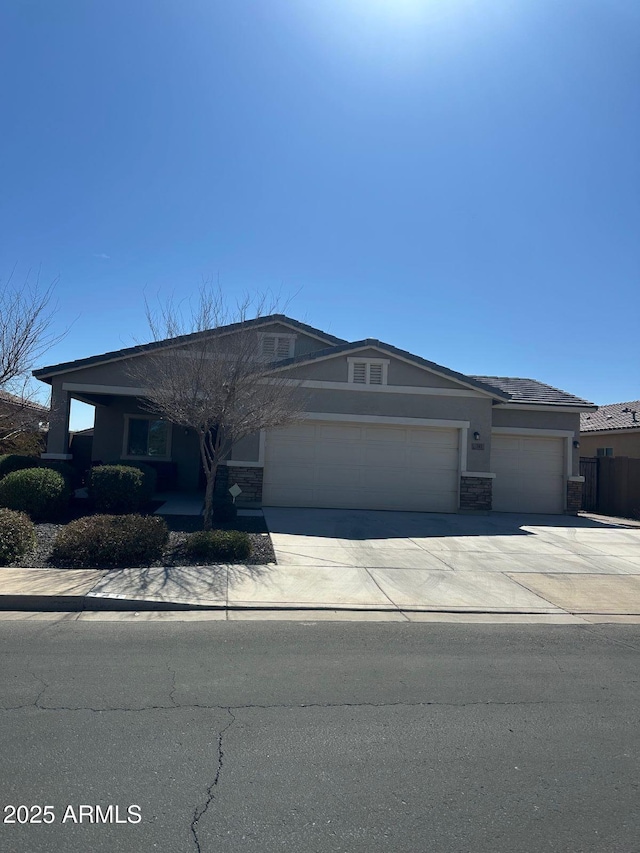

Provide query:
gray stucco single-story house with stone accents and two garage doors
left=34, top=314, right=596, bottom=513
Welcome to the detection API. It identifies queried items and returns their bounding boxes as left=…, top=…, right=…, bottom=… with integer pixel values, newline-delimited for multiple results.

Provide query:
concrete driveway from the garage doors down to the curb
left=264, top=508, right=640, bottom=614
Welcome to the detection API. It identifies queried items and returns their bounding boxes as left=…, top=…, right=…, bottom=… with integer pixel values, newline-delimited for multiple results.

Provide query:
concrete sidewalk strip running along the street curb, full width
left=0, top=565, right=640, bottom=617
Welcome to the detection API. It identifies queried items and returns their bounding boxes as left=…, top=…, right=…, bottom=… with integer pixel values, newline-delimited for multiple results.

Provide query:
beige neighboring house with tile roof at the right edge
left=580, top=400, right=640, bottom=459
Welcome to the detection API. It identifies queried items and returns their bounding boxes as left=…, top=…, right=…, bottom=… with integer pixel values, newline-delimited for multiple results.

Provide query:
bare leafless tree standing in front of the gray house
left=129, top=282, right=302, bottom=530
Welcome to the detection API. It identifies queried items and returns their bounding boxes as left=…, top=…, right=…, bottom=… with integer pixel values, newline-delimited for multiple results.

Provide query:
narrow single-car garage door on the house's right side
left=491, top=434, right=565, bottom=513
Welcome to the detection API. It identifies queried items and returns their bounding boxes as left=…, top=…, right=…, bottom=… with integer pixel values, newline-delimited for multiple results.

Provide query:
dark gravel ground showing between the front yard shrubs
left=6, top=514, right=276, bottom=569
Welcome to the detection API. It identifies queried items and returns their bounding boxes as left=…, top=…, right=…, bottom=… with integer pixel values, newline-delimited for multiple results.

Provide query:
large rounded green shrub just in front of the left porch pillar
left=0, top=468, right=71, bottom=521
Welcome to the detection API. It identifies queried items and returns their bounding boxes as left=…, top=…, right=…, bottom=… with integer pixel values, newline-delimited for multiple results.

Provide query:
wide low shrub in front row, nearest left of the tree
left=51, top=515, right=169, bottom=569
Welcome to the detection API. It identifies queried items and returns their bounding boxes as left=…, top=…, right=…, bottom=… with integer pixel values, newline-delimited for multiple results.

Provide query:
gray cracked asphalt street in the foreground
left=0, top=621, right=640, bottom=853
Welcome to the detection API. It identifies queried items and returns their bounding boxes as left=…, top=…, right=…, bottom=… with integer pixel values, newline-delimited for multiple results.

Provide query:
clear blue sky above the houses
left=0, top=0, right=640, bottom=428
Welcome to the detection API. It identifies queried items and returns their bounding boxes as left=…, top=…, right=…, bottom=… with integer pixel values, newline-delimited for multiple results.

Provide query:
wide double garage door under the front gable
left=263, top=422, right=458, bottom=512
